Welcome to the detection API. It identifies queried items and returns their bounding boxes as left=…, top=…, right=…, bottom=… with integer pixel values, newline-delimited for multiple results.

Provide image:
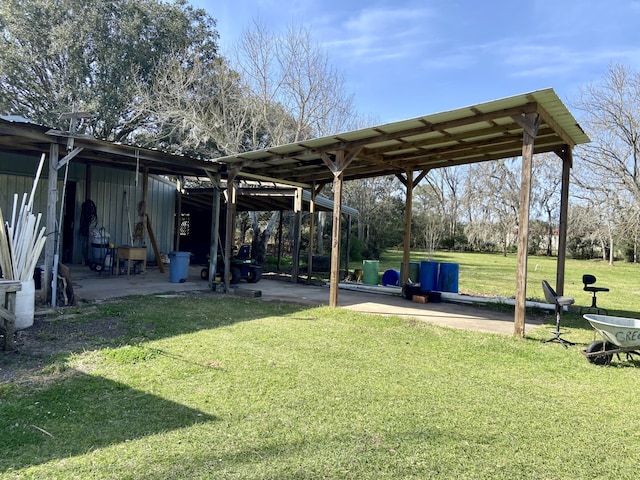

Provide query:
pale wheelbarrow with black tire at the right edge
left=582, top=313, right=640, bottom=365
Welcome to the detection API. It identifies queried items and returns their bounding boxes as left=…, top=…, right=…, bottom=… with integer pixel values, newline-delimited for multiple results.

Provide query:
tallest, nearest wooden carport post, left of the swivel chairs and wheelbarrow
left=513, top=113, right=540, bottom=337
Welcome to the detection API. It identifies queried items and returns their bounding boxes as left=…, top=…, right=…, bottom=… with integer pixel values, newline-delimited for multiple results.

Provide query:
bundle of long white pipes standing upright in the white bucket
left=0, top=154, right=46, bottom=282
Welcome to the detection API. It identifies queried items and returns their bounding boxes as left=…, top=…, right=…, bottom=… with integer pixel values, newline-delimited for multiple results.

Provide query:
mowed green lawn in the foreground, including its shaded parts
left=0, top=286, right=640, bottom=479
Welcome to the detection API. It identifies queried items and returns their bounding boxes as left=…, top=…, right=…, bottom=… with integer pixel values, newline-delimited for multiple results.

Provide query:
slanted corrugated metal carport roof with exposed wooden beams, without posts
left=215, top=89, right=589, bottom=187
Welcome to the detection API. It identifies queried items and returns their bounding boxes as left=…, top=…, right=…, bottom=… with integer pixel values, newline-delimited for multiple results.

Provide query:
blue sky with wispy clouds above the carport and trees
left=191, top=0, right=640, bottom=123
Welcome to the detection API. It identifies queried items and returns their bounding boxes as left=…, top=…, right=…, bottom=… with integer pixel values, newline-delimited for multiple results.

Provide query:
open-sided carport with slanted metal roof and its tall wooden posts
left=216, top=89, right=589, bottom=335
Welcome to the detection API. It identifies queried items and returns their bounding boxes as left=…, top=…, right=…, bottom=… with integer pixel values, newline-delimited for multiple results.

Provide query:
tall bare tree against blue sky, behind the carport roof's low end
left=232, top=21, right=355, bottom=145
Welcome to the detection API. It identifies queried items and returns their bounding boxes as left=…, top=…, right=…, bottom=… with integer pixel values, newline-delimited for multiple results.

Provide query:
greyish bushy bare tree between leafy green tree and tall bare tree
left=134, top=52, right=264, bottom=157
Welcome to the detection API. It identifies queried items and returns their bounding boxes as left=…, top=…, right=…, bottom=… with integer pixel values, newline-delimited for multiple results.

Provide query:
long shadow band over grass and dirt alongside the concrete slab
left=0, top=294, right=308, bottom=385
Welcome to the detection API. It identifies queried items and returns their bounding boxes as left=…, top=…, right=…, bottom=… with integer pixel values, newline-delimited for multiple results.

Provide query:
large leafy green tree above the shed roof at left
left=0, top=0, right=218, bottom=141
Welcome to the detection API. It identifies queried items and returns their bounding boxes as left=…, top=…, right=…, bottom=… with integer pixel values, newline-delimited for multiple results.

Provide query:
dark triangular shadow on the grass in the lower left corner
left=0, top=371, right=216, bottom=471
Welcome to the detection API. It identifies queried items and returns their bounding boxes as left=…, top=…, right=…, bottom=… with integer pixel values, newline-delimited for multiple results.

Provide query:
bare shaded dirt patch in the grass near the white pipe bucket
left=0, top=312, right=134, bottom=383
